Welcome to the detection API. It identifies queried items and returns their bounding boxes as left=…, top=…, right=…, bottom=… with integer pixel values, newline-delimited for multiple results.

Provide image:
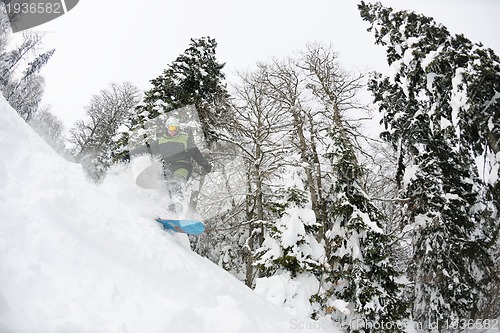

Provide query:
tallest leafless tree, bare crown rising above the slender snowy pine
left=296, top=44, right=366, bottom=243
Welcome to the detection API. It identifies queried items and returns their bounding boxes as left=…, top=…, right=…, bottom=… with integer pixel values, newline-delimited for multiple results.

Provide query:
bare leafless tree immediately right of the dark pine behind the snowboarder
left=213, top=64, right=289, bottom=286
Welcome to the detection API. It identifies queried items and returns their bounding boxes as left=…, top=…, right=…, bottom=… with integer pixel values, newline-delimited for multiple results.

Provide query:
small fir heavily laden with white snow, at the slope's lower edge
left=255, top=167, right=325, bottom=318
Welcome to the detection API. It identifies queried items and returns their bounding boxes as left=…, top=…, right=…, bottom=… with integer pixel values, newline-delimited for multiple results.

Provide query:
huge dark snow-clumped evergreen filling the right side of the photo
left=359, top=2, right=500, bottom=323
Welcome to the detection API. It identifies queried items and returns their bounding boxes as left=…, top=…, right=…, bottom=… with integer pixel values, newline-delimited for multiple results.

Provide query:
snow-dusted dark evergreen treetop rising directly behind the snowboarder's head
left=136, top=37, right=229, bottom=142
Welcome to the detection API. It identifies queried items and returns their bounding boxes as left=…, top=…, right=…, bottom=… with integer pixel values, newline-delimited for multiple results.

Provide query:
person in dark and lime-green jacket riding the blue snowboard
left=130, top=117, right=212, bottom=206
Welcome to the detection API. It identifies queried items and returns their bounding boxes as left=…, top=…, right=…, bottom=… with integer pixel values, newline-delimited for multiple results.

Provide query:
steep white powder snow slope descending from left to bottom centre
left=0, top=95, right=316, bottom=333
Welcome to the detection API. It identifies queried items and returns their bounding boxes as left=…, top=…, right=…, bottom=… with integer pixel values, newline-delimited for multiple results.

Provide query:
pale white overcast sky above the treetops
left=32, top=0, right=500, bottom=127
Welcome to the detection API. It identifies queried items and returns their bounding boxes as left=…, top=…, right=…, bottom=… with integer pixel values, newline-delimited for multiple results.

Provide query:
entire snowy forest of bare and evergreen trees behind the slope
left=0, top=2, right=500, bottom=332
